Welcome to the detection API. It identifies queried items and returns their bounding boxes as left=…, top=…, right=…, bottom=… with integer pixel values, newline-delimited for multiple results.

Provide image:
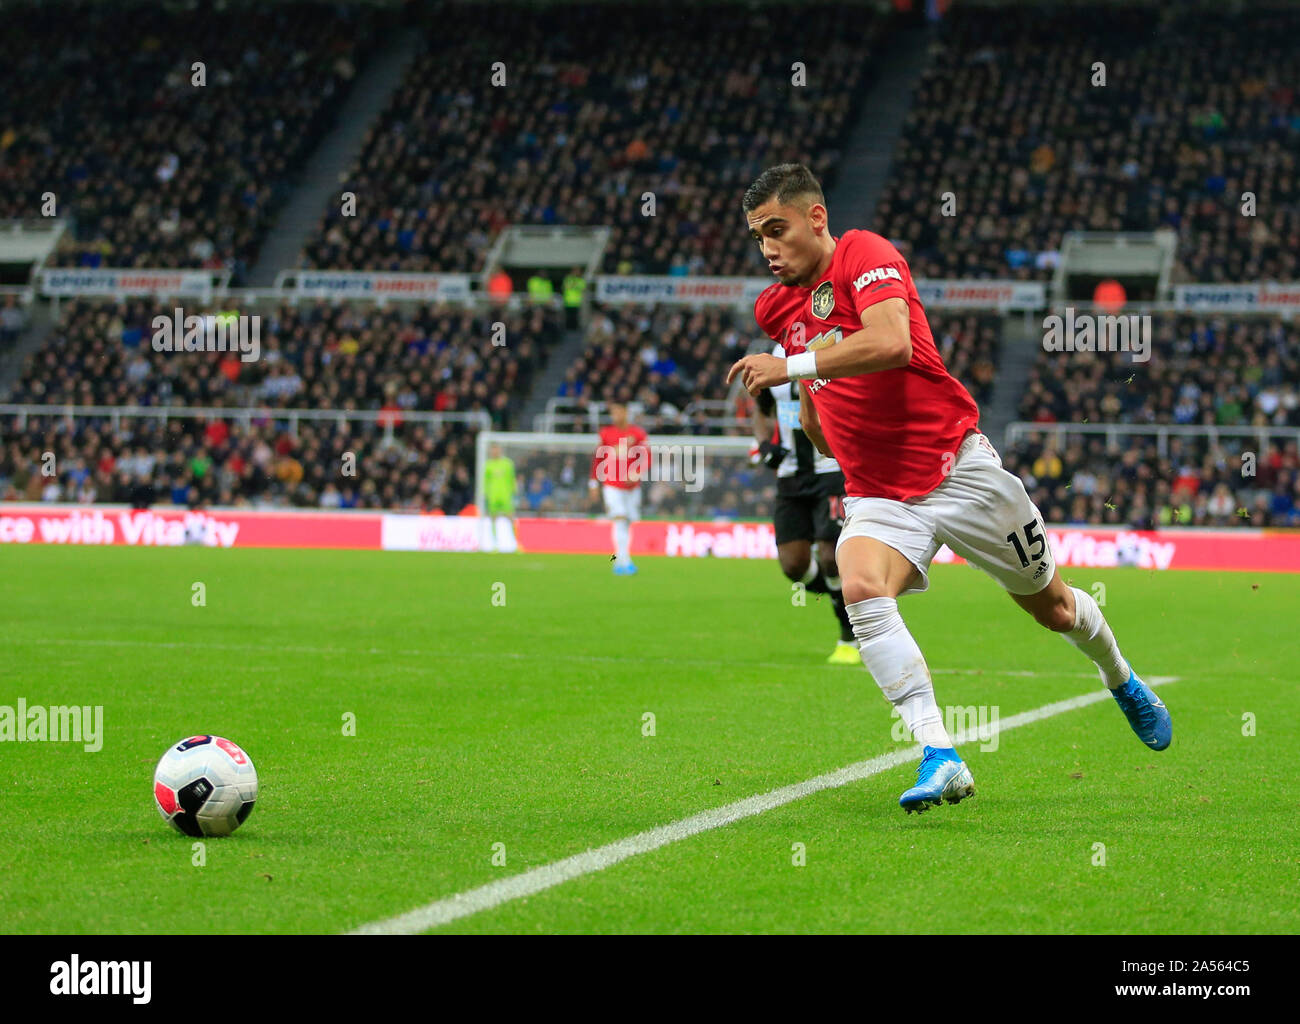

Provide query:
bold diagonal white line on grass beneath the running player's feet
left=348, top=676, right=1179, bottom=936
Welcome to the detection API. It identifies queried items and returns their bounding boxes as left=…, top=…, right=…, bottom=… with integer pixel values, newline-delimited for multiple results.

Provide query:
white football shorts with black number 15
left=836, top=433, right=1056, bottom=595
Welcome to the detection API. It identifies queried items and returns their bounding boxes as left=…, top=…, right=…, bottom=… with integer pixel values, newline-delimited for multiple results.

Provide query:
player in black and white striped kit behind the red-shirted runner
left=754, top=346, right=862, bottom=665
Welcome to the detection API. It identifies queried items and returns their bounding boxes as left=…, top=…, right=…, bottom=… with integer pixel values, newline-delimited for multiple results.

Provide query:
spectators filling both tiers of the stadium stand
left=0, top=4, right=1300, bottom=526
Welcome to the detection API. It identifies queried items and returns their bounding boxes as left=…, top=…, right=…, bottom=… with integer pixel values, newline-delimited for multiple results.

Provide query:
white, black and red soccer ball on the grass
left=153, top=736, right=257, bottom=836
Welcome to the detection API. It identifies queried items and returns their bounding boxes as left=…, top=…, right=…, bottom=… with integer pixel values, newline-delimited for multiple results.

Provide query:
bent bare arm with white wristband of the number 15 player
left=727, top=295, right=911, bottom=395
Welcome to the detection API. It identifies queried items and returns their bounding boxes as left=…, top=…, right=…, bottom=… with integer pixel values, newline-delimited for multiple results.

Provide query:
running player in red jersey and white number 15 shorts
left=727, top=164, right=1171, bottom=812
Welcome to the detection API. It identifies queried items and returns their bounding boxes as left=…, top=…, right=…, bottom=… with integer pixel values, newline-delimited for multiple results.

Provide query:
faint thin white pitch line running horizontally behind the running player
left=5, top=637, right=1097, bottom=680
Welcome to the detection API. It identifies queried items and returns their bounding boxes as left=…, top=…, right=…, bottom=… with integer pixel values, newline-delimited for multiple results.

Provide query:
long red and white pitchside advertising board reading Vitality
left=0, top=503, right=1300, bottom=572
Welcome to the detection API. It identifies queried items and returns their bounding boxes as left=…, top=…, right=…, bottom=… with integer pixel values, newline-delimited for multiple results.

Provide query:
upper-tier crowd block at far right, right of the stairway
left=873, top=4, right=1300, bottom=281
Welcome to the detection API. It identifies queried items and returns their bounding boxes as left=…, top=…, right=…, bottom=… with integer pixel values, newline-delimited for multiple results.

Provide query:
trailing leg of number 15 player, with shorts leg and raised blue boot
left=924, top=434, right=1171, bottom=750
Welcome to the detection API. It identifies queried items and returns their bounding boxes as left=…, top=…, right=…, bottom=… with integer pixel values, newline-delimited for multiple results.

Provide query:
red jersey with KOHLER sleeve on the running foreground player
left=754, top=231, right=979, bottom=502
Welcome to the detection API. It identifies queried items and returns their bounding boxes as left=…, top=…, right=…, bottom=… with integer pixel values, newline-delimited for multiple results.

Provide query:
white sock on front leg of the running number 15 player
left=845, top=598, right=953, bottom=749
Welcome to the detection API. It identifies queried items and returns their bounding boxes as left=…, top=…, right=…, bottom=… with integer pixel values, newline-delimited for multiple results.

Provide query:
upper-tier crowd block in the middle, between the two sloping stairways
left=302, top=0, right=884, bottom=275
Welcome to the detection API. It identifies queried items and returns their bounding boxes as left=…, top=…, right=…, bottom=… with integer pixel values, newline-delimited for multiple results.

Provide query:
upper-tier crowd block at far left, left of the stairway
left=0, top=3, right=376, bottom=283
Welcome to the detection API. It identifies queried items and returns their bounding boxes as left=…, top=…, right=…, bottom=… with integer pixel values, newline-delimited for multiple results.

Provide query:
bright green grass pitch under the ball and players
left=0, top=547, right=1300, bottom=933
